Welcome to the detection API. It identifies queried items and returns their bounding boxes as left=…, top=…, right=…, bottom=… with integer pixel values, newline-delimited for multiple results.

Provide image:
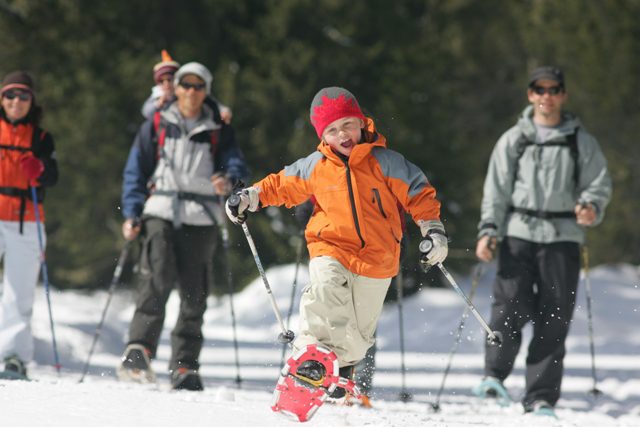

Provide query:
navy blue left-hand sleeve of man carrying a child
left=122, top=121, right=157, bottom=218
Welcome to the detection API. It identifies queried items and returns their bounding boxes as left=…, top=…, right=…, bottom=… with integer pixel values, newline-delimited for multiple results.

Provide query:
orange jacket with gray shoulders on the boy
left=254, top=118, right=440, bottom=278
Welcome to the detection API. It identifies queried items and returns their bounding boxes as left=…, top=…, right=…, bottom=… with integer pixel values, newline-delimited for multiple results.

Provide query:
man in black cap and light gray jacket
left=474, top=66, right=611, bottom=415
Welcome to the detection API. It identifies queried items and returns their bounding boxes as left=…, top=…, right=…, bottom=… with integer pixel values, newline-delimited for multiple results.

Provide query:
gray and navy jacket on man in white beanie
left=122, top=103, right=248, bottom=227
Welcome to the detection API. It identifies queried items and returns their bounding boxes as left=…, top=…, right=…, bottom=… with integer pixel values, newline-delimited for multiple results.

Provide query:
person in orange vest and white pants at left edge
left=0, top=71, right=58, bottom=377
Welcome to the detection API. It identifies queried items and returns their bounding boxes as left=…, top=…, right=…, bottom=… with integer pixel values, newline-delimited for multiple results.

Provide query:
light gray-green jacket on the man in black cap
left=478, top=106, right=611, bottom=243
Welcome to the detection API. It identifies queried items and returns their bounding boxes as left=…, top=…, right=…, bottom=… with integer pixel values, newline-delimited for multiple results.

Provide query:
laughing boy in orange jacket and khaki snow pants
left=226, top=87, right=448, bottom=397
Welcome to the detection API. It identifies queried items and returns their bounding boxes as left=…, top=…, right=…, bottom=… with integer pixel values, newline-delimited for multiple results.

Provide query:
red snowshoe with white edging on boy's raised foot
left=271, top=344, right=360, bottom=422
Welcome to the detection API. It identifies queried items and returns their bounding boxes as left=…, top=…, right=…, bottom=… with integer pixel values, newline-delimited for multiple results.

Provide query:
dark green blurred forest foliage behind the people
left=0, top=0, right=640, bottom=293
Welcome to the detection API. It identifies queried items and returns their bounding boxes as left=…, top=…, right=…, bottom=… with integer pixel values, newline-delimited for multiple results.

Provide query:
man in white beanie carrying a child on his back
left=117, top=62, right=247, bottom=390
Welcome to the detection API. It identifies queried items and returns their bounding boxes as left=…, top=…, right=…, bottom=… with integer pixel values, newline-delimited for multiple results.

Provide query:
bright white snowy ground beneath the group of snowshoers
left=0, top=265, right=640, bottom=427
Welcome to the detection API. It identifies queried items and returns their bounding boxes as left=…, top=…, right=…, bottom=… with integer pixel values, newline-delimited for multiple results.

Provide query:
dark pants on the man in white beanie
left=129, top=218, right=216, bottom=370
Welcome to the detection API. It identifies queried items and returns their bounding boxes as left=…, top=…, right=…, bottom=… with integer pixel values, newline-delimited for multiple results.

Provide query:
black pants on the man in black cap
left=485, top=237, right=580, bottom=407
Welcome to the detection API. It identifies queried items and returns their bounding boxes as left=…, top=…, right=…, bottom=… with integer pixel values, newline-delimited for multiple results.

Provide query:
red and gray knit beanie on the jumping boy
left=309, top=87, right=365, bottom=139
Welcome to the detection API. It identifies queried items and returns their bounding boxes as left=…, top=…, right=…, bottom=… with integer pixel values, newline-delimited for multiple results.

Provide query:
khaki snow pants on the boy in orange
left=293, top=256, right=391, bottom=367
